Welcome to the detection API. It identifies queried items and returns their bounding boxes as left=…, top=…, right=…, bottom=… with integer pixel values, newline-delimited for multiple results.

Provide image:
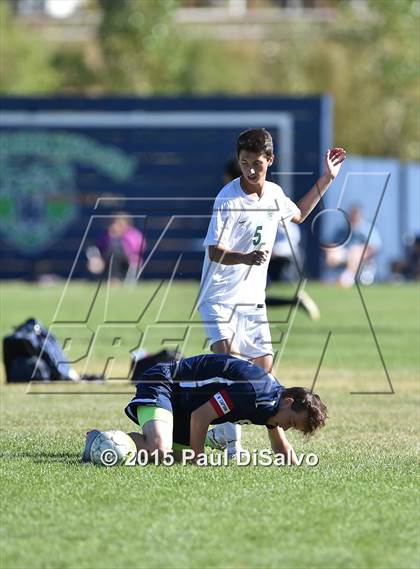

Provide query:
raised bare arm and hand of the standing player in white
left=292, top=148, right=346, bottom=223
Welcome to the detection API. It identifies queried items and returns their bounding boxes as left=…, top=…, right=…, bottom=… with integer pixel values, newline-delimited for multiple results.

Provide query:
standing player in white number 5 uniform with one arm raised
left=197, top=128, right=346, bottom=454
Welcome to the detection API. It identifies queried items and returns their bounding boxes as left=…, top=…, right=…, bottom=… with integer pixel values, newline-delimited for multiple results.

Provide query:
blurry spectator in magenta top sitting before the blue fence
left=87, top=212, right=146, bottom=283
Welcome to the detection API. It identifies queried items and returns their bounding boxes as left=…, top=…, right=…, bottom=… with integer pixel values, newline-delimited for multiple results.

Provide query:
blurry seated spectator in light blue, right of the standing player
left=325, top=206, right=381, bottom=288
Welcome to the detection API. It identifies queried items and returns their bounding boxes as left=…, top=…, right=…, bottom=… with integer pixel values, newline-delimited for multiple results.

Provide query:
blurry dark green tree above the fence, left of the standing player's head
left=98, top=0, right=189, bottom=94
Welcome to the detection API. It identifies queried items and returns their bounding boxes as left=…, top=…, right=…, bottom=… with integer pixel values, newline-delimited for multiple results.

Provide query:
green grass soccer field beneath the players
left=0, top=283, right=420, bottom=569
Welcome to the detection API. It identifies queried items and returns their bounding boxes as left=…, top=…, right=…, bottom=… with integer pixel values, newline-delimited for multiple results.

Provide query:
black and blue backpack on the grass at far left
left=3, top=318, right=74, bottom=383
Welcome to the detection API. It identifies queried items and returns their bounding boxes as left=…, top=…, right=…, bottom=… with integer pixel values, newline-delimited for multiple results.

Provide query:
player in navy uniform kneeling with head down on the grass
left=120, top=354, right=327, bottom=464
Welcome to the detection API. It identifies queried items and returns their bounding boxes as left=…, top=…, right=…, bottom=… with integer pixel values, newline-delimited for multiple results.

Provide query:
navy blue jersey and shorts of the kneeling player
left=126, top=354, right=284, bottom=442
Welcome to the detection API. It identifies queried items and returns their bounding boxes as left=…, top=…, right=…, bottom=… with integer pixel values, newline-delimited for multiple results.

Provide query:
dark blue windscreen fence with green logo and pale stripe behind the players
left=0, top=96, right=332, bottom=279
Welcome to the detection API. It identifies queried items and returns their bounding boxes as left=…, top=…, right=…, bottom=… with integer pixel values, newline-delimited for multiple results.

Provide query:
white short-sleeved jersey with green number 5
left=198, top=178, right=299, bottom=306
